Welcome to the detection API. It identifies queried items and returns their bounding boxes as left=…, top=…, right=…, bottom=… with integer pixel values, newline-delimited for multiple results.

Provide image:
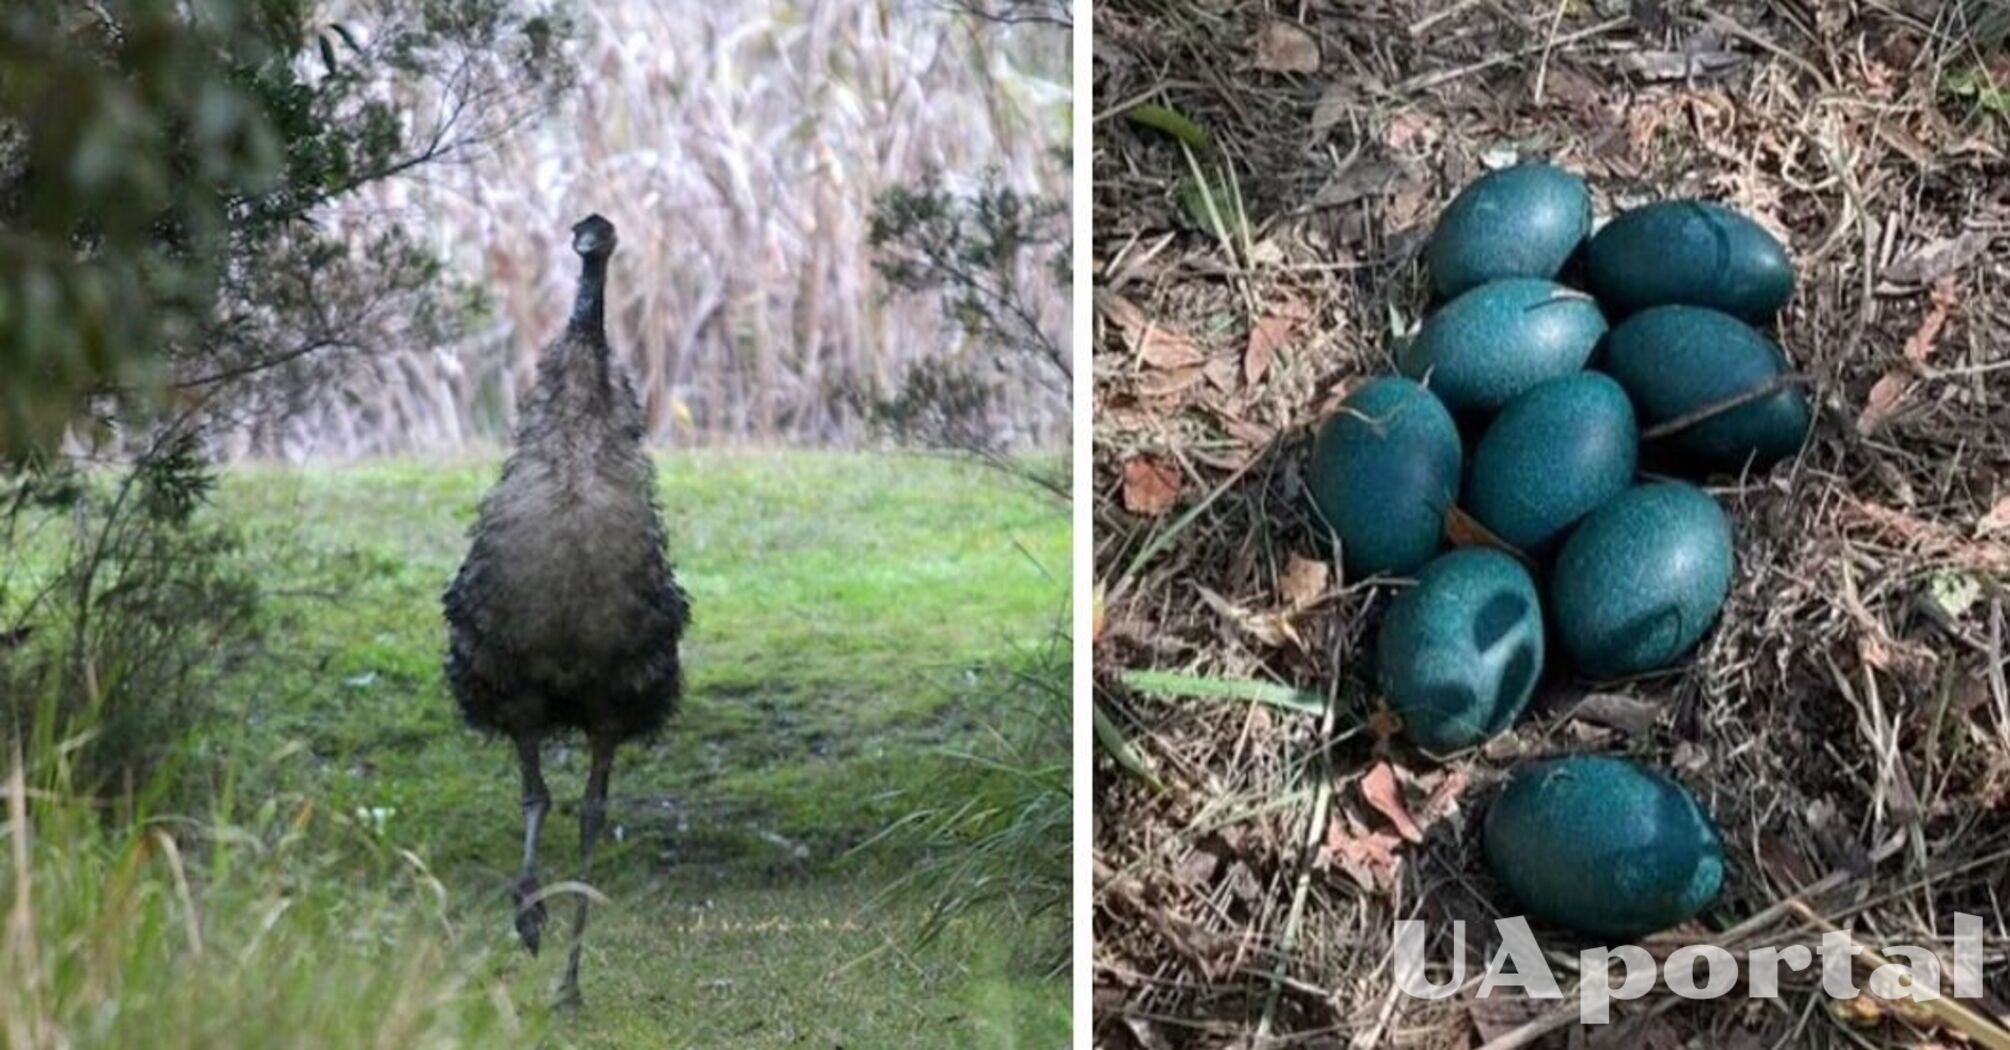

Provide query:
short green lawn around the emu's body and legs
left=11, top=453, right=1067, bottom=1048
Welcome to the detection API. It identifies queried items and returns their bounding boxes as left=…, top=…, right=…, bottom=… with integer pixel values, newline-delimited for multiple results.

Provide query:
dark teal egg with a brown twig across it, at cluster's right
left=1604, top=306, right=1815, bottom=473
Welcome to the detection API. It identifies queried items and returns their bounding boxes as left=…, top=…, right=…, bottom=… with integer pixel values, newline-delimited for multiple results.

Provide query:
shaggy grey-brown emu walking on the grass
left=444, top=215, right=689, bottom=1006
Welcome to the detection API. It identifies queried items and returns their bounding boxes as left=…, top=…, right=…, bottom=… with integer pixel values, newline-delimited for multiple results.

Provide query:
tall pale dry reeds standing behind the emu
left=229, top=0, right=1069, bottom=457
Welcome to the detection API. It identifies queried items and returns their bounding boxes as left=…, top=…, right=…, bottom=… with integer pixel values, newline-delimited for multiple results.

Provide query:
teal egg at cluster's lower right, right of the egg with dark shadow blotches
left=1550, top=481, right=1731, bottom=678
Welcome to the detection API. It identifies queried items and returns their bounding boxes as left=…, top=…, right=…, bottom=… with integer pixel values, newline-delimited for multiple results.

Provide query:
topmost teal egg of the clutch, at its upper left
left=1425, top=165, right=1592, bottom=300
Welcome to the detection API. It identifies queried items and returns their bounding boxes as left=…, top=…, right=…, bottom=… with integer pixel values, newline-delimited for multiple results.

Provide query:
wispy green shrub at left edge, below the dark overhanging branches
left=0, top=439, right=257, bottom=793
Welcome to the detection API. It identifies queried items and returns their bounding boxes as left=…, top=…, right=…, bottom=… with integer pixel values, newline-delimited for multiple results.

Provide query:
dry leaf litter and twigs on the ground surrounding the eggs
left=1093, top=0, right=2010, bottom=1050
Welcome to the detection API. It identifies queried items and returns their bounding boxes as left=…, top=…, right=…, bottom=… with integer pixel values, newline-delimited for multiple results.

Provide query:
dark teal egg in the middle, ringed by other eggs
left=1465, top=372, right=1640, bottom=553
